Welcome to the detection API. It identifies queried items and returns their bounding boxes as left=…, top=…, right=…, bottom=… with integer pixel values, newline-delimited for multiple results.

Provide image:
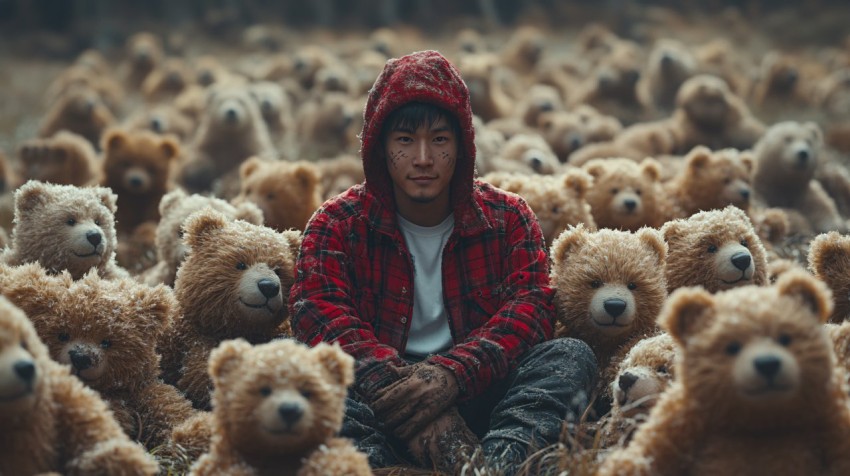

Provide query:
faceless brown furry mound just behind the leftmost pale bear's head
left=18, top=131, right=102, bottom=187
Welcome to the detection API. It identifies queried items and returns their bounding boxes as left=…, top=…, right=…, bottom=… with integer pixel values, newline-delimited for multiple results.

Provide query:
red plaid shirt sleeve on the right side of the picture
left=428, top=199, right=555, bottom=401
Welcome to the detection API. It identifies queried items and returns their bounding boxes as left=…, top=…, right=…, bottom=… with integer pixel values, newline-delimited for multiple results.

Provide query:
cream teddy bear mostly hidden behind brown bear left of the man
left=138, top=188, right=263, bottom=286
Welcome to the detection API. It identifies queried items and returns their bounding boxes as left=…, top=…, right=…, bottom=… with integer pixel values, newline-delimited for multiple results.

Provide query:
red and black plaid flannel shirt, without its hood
left=289, top=181, right=554, bottom=400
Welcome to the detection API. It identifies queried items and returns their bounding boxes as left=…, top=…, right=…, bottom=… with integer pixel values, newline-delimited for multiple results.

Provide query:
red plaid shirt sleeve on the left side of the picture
left=289, top=209, right=406, bottom=401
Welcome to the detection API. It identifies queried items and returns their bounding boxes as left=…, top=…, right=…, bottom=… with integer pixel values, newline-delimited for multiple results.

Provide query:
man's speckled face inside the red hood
left=385, top=118, right=458, bottom=211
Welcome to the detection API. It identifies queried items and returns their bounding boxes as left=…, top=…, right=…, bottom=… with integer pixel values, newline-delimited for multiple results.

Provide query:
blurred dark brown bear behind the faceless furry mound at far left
left=38, top=86, right=116, bottom=147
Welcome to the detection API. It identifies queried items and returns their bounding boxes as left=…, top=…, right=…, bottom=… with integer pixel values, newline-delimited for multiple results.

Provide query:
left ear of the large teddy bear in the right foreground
left=658, top=287, right=714, bottom=346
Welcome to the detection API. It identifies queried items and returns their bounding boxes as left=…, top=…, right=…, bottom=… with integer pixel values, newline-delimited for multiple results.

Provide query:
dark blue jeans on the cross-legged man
left=340, top=338, right=596, bottom=468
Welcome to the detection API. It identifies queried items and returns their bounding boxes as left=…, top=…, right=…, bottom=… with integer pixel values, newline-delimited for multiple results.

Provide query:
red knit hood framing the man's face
left=360, top=51, right=475, bottom=209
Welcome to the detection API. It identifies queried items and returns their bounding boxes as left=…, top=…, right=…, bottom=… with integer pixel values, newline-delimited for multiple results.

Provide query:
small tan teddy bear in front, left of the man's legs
left=190, top=339, right=372, bottom=476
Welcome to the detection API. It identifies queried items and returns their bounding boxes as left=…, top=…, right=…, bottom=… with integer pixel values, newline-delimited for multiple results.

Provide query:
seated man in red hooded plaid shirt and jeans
left=289, top=51, right=596, bottom=471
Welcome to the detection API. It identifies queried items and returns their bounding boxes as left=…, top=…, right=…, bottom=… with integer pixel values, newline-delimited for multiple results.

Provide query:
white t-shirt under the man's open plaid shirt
left=398, top=214, right=455, bottom=357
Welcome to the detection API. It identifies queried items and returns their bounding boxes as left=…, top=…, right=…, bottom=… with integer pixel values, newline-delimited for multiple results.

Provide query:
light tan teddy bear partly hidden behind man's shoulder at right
left=481, top=169, right=596, bottom=245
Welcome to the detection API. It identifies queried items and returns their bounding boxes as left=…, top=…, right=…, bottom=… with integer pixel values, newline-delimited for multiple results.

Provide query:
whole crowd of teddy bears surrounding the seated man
left=0, top=4, right=850, bottom=475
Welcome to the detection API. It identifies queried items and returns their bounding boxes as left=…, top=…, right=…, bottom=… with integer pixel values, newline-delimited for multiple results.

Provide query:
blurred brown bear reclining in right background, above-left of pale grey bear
left=670, top=74, right=765, bottom=154
